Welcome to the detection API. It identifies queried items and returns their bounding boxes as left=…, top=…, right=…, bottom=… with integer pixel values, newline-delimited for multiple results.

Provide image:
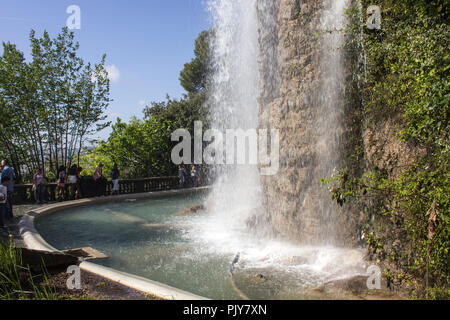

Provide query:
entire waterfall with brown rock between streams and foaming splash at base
left=185, top=0, right=368, bottom=297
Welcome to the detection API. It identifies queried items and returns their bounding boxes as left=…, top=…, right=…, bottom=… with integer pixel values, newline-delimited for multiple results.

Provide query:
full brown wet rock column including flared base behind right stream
left=259, top=0, right=359, bottom=245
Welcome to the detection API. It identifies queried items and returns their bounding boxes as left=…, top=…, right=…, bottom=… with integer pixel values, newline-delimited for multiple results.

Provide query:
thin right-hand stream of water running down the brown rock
left=303, top=0, right=349, bottom=244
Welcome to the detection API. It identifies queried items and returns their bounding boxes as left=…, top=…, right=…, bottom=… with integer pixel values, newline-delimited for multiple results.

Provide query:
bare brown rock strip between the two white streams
left=260, top=0, right=321, bottom=242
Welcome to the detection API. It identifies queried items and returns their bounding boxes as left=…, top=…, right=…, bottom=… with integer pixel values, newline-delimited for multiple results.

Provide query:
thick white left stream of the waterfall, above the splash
left=204, top=0, right=261, bottom=236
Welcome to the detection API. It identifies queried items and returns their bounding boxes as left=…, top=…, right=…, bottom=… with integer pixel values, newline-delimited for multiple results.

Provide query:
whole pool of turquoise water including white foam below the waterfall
left=36, top=195, right=365, bottom=299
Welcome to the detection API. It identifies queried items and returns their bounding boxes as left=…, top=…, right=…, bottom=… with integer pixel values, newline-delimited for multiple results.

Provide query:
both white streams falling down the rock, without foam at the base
left=203, top=0, right=356, bottom=244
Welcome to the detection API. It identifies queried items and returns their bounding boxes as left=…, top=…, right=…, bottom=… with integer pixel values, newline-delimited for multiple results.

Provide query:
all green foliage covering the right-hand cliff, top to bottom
left=323, top=0, right=450, bottom=299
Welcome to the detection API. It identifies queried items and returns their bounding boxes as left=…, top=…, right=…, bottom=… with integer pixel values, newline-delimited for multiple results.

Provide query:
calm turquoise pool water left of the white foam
left=36, top=192, right=244, bottom=299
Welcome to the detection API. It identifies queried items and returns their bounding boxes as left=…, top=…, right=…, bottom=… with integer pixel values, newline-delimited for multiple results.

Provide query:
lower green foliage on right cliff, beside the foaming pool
left=324, top=161, right=450, bottom=297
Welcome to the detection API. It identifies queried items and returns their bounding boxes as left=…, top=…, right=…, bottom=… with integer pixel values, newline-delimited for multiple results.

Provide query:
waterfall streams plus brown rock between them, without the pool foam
left=200, top=0, right=358, bottom=249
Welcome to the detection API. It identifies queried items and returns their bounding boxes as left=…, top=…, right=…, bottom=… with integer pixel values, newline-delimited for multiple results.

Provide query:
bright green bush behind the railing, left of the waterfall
left=80, top=117, right=175, bottom=178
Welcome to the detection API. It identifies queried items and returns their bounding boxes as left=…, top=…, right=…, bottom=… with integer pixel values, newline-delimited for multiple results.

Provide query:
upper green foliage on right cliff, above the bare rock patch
left=363, top=0, right=450, bottom=152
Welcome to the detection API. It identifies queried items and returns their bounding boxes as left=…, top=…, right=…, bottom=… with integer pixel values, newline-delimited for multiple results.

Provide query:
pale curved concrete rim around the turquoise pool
left=19, top=187, right=209, bottom=300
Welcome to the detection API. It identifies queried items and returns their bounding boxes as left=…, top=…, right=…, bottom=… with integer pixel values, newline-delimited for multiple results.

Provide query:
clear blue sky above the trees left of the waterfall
left=0, top=0, right=211, bottom=137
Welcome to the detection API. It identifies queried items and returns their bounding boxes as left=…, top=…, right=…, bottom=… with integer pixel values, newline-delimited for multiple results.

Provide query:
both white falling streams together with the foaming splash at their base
left=188, top=0, right=368, bottom=296
